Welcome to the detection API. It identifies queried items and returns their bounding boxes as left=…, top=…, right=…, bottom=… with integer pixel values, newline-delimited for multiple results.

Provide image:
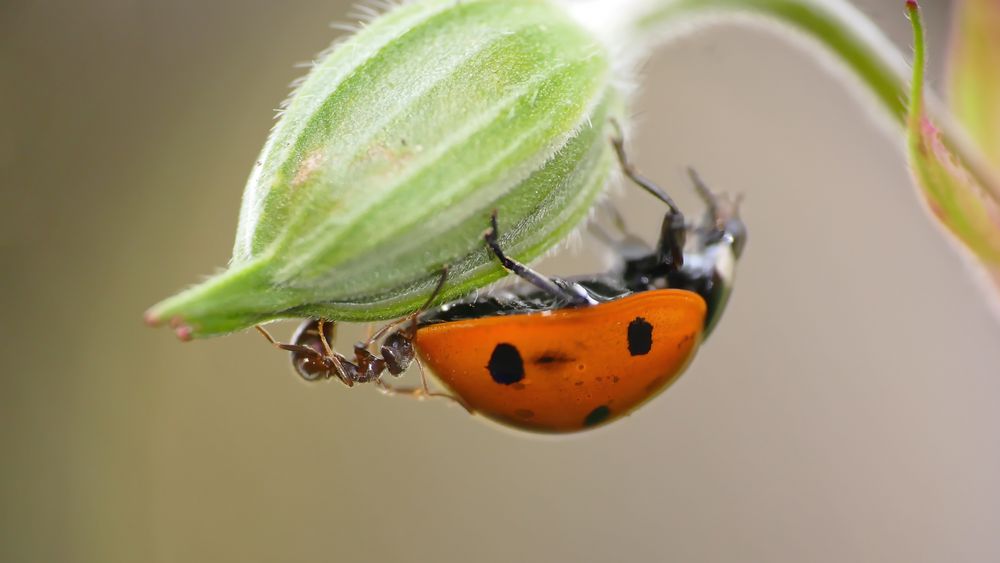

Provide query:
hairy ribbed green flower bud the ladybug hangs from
left=147, top=0, right=622, bottom=337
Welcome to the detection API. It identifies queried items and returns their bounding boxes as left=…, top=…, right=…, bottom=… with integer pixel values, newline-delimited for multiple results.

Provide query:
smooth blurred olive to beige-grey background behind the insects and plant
left=7, top=0, right=1000, bottom=563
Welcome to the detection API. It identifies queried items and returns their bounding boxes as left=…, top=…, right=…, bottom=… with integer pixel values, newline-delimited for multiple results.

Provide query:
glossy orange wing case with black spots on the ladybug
left=414, top=289, right=706, bottom=432
